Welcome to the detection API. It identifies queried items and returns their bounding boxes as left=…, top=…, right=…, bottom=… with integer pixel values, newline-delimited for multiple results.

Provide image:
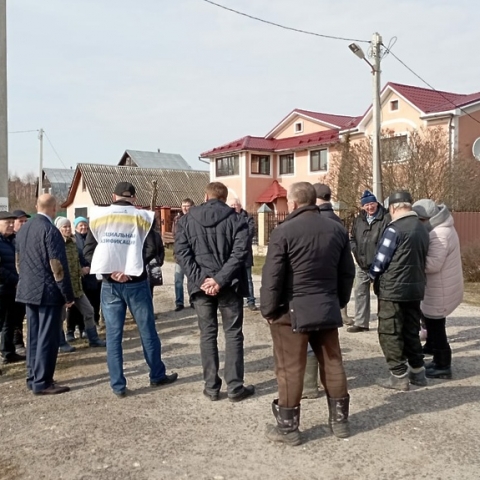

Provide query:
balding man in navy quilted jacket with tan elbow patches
left=16, top=194, right=74, bottom=395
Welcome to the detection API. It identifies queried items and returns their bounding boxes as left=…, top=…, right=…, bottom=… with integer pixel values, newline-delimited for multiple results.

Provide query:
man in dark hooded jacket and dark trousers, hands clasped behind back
left=175, top=182, right=255, bottom=402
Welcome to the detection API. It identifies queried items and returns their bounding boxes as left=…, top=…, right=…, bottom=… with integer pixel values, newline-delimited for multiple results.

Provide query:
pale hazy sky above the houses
left=7, top=0, right=480, bottom=175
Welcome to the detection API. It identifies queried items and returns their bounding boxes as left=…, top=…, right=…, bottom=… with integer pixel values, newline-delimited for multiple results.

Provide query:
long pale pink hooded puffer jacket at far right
left=422, top=205, right=463, bottom=318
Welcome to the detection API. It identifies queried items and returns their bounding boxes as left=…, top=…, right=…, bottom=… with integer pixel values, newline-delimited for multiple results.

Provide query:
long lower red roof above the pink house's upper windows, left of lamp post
left=200, top=130, right=338, bottom=157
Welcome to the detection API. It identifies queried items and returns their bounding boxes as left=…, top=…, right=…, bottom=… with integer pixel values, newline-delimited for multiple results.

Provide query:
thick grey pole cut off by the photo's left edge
left=0, top=0, right=8, bottom=211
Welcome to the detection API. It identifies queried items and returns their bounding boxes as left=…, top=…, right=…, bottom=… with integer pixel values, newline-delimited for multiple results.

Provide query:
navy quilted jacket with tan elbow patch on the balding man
left=15, top=214, right=74, bottom=305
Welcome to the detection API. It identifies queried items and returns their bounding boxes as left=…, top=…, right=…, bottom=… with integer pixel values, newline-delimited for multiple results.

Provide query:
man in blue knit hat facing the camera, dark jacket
left=347, top=190, right=390, bottom=333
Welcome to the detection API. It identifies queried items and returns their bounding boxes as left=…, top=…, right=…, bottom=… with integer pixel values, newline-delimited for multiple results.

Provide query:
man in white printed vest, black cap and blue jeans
left=84, top=182, right=178, bottom=397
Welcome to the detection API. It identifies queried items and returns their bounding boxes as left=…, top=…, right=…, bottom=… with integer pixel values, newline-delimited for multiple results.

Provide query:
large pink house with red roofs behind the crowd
left=201, top=83, right=480, bottom=212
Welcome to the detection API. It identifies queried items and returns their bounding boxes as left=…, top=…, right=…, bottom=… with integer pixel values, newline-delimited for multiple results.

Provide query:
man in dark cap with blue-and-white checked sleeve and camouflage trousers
left=369, top=191, right=429, bottom=391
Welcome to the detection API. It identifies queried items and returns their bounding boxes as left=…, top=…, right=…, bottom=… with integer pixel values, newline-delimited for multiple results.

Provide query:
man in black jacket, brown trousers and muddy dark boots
left=260, top=182, right=355, bottom=445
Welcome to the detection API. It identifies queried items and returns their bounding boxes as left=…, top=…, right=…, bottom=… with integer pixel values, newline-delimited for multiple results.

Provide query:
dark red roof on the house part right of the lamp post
left=385, top=82, right=480, bottom=113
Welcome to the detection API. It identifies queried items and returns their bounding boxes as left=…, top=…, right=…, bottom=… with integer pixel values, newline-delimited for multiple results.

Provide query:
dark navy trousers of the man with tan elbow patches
left=27, top=304, right=63, bottom=392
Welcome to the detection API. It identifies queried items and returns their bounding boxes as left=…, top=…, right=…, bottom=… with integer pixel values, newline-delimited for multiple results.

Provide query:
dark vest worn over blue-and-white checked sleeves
left=378, top=214, right=430, bottom=302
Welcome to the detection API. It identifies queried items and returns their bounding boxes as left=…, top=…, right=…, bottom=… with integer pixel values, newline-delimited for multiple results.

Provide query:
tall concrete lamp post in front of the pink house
left=348, top=33, right=383, bottom=203
